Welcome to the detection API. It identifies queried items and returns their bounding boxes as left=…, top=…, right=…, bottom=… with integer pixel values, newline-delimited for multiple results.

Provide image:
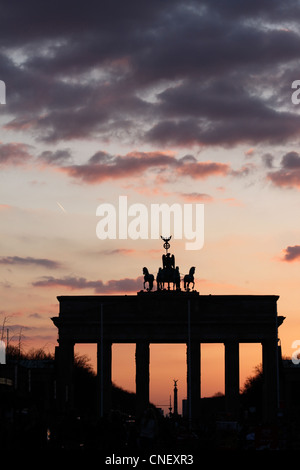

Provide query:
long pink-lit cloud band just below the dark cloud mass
left=0, top=140, right=254, bottom=185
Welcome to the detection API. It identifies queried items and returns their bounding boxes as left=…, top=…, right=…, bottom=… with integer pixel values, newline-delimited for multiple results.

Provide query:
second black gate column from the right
left=225, top=341, right=240, bottom=419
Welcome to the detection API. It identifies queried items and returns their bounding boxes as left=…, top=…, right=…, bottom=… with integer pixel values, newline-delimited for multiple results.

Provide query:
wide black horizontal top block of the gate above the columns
left=52, top=291, right=284, bottom=343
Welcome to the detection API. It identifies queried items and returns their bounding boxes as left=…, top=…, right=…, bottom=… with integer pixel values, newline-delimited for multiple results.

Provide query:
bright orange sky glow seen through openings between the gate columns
left=75, top=343, right=262, bottom=413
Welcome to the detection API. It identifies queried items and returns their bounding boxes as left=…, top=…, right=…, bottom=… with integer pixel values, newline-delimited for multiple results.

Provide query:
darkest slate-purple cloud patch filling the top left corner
left=0, top=0, right=176, bottom=47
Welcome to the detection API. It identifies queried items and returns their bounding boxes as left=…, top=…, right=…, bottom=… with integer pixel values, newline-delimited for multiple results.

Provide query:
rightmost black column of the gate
left=262, top=339, right=278, bottom=424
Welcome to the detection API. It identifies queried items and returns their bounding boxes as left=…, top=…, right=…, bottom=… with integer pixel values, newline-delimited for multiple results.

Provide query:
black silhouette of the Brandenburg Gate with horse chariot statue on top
left=52, top=237, right=284, bottom=424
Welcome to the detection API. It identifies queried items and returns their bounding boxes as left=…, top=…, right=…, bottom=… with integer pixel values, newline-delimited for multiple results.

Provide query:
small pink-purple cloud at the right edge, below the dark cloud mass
left=267, top=151, right=300, bottom=188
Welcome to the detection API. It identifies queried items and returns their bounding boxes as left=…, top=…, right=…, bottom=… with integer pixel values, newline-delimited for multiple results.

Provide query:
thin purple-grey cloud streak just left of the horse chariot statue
left=32, top=276, right=143, bottom=294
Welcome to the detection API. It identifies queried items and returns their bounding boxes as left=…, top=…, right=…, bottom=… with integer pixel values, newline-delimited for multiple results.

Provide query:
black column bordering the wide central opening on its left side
left=135, top=341, right=150, bottom=417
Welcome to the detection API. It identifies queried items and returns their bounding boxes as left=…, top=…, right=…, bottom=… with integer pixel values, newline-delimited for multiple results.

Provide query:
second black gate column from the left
left=97, top=340, right=112, bottom=418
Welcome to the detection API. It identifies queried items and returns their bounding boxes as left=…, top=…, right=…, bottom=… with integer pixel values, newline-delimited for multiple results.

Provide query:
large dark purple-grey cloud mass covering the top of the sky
left=0, top=0, right=300, bottom=147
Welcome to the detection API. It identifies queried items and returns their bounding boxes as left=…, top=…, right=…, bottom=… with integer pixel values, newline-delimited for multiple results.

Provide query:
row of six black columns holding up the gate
left=58, top=340, right=278, bottom=423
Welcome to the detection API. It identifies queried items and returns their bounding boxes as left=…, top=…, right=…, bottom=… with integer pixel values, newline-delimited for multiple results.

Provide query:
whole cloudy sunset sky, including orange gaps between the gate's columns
left=0, top=0, right=300, bottom=412
